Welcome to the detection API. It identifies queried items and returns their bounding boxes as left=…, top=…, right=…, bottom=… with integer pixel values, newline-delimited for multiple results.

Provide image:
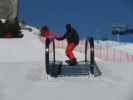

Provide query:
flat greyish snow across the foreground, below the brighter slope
left=0, top=63, right=132, bottom=100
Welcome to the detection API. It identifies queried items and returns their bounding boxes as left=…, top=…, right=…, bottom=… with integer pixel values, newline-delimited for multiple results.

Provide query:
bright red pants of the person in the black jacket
left=65, top=43, right=77, bottom=60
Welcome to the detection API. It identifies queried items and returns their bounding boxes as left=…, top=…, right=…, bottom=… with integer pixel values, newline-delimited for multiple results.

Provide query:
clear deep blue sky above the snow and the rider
left=19, top=0, right=133, bottom=42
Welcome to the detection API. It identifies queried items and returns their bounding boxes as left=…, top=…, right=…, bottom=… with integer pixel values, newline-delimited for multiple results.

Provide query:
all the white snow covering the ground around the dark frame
left=0, top=29, right=133, bottom=100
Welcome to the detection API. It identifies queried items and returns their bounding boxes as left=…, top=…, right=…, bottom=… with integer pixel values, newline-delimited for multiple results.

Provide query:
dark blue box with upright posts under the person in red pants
left=45, top=37, right=102, bottom=77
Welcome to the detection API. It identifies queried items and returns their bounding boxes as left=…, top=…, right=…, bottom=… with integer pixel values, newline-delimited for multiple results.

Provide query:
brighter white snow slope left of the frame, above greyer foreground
left=0, top=27, right=44, bottom=62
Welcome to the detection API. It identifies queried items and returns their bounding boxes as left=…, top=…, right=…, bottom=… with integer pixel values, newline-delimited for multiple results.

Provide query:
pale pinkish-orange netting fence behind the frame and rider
left=55, top=40, right=133, bottom=62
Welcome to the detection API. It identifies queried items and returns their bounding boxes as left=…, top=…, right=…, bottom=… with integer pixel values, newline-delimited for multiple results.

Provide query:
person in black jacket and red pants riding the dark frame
left=56, top=24, right=79, bottom=65
